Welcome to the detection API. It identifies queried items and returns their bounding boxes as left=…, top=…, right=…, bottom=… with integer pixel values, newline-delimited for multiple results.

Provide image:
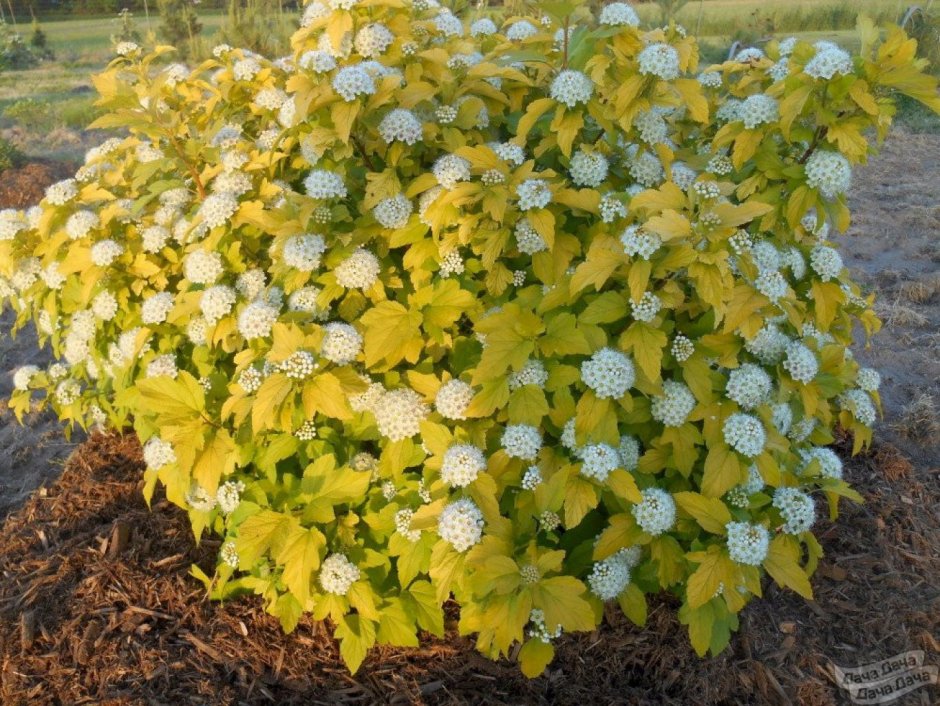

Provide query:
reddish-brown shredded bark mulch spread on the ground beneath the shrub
left=0, top=428, right=940, bottom=706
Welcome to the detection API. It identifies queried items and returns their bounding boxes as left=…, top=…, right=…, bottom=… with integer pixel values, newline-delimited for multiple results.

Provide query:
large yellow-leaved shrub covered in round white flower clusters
left=0, top=0, right=937, bottom=675
